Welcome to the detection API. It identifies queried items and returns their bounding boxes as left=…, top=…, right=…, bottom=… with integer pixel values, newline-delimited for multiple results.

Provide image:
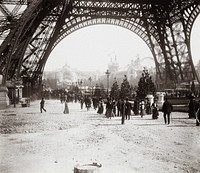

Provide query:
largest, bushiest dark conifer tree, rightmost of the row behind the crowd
left=136, top=69, right=156, bottom=100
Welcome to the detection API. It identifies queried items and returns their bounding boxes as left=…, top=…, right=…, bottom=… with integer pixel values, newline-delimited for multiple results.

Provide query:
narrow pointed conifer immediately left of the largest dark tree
left=120, top=75, right=131, bottom=99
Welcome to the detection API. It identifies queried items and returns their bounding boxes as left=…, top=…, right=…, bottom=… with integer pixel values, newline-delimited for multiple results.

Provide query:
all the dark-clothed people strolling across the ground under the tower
left=40, top=92, right=200, bottom=126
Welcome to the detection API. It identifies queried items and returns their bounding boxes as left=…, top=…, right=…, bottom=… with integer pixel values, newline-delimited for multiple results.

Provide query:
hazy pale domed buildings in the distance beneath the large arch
left=44, top=56, right=155, bottom=87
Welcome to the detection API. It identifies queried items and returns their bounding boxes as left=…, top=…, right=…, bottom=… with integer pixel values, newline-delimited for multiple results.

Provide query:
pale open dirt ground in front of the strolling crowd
left=0, top=100, right=200, bottom=173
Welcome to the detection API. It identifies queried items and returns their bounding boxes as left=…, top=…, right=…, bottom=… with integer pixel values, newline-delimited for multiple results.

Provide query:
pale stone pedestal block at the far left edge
left=0, top=85, right=9, bottom=110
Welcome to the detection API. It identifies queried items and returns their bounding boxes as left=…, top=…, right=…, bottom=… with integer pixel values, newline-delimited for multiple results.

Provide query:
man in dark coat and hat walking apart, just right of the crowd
left=162, top=97, right=173, bottom=124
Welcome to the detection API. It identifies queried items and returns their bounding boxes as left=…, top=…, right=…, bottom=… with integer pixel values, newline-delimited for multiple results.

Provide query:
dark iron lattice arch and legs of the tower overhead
left=0, top=0, right=200, bottom=89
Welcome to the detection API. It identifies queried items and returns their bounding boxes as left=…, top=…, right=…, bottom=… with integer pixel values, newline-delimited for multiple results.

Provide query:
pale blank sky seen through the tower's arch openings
left=44, top=16, right=200, bottom=71
